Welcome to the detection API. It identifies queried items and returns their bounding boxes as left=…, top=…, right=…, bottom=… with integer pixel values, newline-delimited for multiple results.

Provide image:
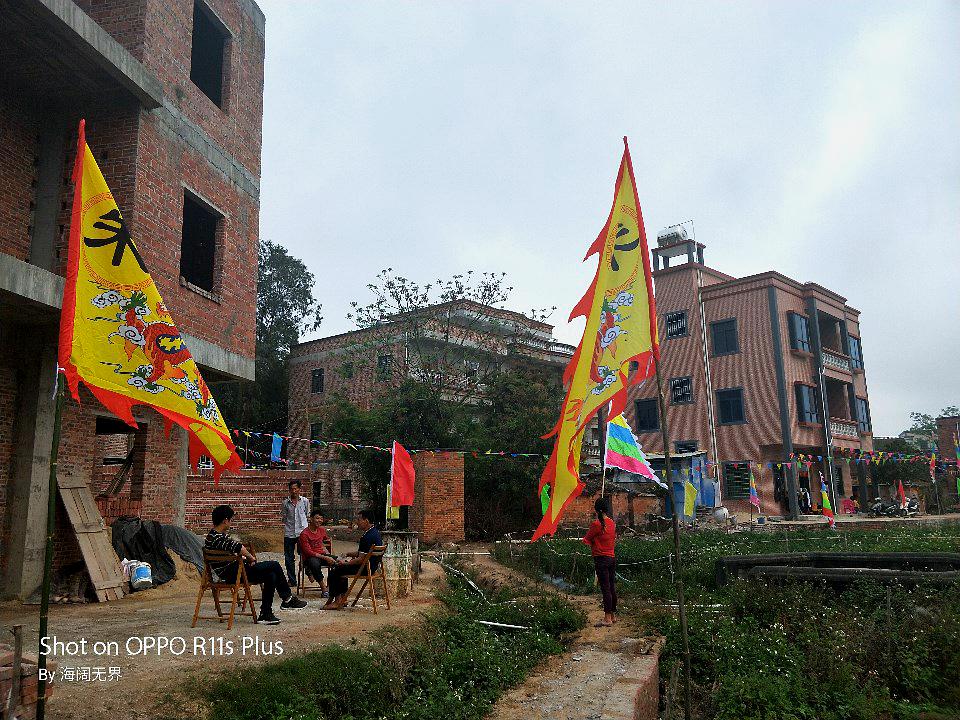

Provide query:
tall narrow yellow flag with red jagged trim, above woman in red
left=533, top=138, right=659, bottom=540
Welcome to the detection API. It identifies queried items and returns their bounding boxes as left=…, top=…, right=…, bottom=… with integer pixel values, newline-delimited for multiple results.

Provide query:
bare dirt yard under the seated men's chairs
left=0, top=553, right=441, bottom=720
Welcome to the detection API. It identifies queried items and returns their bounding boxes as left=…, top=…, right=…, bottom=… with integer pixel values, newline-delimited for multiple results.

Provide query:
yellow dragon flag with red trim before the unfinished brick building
left=59, top=120, right=243, bottom=477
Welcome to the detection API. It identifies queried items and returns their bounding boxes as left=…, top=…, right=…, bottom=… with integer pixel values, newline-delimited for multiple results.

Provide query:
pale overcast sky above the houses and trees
left=259, top=0, right=960, bottom=435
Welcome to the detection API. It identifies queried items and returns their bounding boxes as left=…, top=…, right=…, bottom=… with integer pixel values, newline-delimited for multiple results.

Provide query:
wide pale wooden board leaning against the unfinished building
left=57, top=478, right=125, bottom=602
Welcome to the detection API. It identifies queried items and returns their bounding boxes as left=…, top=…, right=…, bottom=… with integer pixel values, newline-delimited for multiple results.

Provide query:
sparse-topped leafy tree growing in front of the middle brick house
left=321, top=268, right=563, bottom=536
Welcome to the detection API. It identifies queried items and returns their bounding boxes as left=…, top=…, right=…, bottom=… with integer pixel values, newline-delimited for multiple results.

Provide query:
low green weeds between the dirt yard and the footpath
left=199, top=574, right=585, bottom=720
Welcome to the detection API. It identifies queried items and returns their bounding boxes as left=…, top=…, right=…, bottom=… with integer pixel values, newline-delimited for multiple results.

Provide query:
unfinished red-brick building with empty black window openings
left=0, top=0, right=264, bottom=598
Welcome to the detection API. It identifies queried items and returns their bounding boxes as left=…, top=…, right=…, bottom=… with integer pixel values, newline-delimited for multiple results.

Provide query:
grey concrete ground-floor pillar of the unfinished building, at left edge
left=0, top=326, right=57, bottom=600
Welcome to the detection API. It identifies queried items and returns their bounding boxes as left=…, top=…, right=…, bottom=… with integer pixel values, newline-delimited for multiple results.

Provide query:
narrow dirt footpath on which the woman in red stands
left=464, top=555, right=652, bottom=720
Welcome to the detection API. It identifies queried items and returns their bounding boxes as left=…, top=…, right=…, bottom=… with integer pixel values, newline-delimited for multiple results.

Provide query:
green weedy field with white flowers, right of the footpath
left=495, top=527, right=960, bottom=720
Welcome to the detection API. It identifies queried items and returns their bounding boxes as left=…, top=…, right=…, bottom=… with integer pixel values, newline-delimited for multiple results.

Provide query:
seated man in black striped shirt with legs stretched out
left=203, top=505, right=307, bottom=625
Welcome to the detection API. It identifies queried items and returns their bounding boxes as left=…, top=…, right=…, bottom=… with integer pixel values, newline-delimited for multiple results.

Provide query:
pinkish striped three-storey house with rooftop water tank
left=628, top=226, right=873, bottom=516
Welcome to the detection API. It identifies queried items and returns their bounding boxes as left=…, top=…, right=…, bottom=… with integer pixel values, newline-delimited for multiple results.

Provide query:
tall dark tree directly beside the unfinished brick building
left=217, top=240, right=323, bottom=432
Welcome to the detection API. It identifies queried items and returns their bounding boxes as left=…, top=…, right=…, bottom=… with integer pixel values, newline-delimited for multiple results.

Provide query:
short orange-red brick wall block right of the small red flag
left=409, top=452, right=464, bottom=543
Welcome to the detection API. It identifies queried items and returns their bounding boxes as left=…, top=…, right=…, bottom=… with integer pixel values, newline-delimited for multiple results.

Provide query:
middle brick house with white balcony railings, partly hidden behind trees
left=288, top=301, right=576, bottom=507
